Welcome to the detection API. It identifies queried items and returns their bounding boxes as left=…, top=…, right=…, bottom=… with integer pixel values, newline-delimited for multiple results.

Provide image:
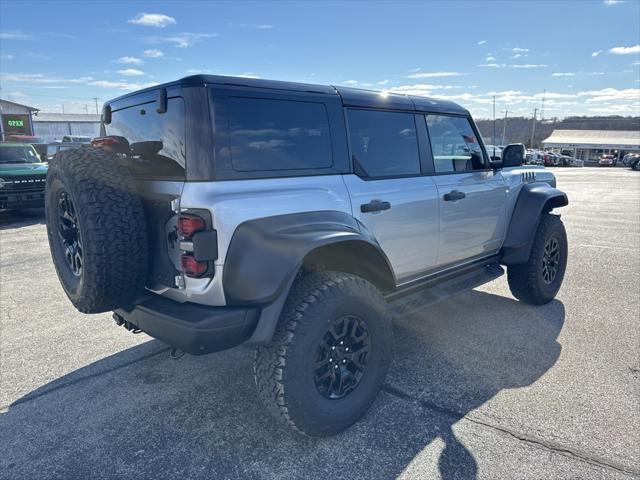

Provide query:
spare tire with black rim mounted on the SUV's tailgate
left=45, top=147, right=148, bottom=313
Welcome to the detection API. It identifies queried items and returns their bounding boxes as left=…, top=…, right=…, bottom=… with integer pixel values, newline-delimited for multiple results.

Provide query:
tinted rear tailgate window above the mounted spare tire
left=105, top=97, right=186, bottom=178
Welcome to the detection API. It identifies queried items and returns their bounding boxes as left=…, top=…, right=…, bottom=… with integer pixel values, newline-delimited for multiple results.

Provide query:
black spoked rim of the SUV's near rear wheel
left=314, top=315, right=371, bottom=399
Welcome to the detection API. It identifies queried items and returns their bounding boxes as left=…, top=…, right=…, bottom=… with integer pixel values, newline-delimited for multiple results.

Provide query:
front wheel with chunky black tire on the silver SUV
left=507, top=213, right=568, bottom=305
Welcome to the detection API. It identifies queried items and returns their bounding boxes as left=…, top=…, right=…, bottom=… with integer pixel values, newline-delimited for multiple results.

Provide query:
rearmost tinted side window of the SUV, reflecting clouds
left=226, top=97, right=333, bottom=172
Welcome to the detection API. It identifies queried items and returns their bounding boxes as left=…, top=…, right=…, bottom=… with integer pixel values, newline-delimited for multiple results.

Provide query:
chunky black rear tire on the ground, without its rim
left=254, top=272, right=393, bottom=436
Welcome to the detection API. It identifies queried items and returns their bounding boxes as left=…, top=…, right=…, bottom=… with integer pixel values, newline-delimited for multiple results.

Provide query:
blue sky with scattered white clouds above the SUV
left=0, top=0, right=640, bottom=118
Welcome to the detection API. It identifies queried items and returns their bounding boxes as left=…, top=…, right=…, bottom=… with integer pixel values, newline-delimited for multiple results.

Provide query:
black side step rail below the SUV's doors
left=387, top=263, right=504, bottom=316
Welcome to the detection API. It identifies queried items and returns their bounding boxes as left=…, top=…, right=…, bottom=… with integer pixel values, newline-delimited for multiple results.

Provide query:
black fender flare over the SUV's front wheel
left=501, top=182, right=569, bottom=265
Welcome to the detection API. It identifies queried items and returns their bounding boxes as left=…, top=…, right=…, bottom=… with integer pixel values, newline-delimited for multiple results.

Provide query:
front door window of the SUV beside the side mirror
left=426, top=115, right=487, bottom=173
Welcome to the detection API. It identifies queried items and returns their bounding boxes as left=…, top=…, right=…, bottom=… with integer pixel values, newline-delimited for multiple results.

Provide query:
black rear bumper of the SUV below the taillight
left=114, top=295, right=260, bottom=355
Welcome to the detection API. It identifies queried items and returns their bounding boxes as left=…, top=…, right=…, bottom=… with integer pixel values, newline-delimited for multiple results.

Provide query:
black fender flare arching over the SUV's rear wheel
left=222, top=211, right=395, bottom=343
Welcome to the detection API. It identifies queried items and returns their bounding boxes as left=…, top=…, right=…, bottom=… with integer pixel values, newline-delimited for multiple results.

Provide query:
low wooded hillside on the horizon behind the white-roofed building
left=476, top=116, right=640, bottom=148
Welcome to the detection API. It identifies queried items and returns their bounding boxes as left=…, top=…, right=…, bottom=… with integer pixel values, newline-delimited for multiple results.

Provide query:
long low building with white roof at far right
left=542, top=130, right=640, bottom=162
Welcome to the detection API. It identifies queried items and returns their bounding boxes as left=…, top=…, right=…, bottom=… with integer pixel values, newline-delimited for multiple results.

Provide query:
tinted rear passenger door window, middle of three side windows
left=347, top=110, right=420, bottom=178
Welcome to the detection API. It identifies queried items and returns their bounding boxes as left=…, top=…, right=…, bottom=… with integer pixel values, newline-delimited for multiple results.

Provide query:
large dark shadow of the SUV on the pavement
left=0, top=291, right=564, bottom=479
